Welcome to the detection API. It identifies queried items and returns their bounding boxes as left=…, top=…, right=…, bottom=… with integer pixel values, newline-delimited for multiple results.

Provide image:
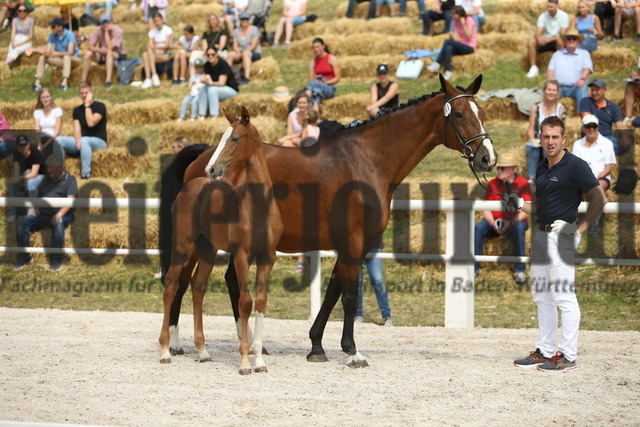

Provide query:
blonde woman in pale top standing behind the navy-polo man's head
left=526, top=80, right=567, bottom=184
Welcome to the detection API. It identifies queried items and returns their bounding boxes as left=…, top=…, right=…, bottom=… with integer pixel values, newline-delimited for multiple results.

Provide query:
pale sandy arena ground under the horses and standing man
left=0, top=308, right=640, bottom=426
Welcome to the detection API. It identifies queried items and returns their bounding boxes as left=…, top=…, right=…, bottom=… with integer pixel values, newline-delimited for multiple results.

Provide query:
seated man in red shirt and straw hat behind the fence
left=475, top=154, right=532, bottom=285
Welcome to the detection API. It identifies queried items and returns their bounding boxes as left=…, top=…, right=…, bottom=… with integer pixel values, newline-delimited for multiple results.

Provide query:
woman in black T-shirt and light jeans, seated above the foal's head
left=198, top=46, right=239, bottom=120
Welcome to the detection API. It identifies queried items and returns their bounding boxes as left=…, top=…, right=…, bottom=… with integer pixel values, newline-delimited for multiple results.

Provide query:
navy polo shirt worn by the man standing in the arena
left=536, top=150, right=600, bottom=225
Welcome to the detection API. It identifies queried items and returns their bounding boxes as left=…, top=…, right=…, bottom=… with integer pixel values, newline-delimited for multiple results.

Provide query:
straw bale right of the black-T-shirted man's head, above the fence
left=107, top=97, right=182, bottom=126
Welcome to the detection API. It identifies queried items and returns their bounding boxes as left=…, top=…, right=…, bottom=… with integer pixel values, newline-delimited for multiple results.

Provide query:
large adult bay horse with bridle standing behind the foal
left=160, top=75, right=497, bottom=367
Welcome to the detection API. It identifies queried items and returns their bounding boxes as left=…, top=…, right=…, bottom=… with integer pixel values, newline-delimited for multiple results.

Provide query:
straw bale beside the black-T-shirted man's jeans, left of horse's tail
left=65, top=147, right=153, bottom=178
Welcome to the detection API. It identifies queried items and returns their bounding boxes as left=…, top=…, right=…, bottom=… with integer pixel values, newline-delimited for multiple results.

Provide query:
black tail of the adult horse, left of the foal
left=158, top=144, right=209, bottom=279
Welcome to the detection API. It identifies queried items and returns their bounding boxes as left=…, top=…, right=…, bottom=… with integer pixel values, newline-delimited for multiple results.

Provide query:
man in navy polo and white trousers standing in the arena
left=505, top=116, right=607, bottom=372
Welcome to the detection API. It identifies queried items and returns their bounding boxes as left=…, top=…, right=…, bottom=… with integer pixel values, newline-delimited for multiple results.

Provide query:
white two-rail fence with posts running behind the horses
left=0, top=197, right=640, bottom=328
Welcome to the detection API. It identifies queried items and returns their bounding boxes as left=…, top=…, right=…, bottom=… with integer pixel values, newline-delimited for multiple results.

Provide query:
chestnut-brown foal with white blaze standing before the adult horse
left=159, top=107, right=283, bottom=375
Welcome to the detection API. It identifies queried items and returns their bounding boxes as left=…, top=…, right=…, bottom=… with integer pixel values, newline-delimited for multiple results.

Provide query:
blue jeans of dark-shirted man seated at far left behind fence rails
left=16, top=213, right=75, bottom=264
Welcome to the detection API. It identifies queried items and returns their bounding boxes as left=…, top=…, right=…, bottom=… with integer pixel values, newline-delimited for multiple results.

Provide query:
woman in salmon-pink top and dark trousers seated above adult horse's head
left=427, top=6, right=478, bottom=80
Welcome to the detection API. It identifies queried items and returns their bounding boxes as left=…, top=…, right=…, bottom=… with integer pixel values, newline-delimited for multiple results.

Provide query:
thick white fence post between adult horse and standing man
left=444, top=208, right=474, bottom=328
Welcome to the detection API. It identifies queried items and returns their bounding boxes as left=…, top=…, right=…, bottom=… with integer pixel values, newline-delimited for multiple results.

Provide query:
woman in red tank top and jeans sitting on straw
left=306, top=37, right=341, bottom=111
